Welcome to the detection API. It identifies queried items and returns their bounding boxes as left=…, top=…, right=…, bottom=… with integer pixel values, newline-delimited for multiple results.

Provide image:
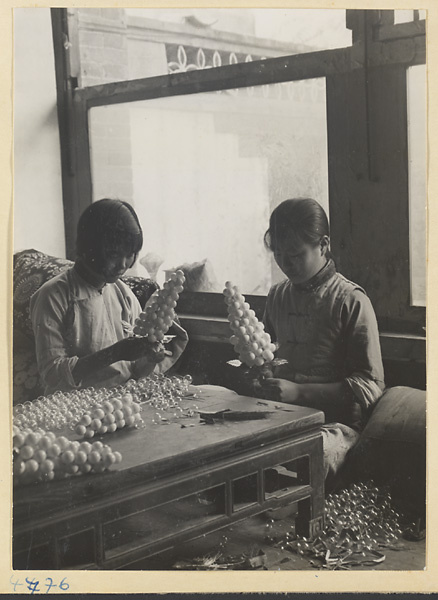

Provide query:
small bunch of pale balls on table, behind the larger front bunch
left=75, top=392, right=142, bottom=438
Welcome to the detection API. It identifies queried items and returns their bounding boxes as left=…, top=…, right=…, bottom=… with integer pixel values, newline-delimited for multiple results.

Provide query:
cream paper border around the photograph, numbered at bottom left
left=0, top=0, right=438, bottom=594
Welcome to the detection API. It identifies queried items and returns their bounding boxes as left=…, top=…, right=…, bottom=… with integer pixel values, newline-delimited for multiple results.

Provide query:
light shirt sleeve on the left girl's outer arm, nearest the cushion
left=30, top=286, right=79, bottom=391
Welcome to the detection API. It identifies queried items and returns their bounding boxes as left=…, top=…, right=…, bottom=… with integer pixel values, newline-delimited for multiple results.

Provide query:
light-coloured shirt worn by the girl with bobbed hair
left=30, top=267, right=187, bottom=394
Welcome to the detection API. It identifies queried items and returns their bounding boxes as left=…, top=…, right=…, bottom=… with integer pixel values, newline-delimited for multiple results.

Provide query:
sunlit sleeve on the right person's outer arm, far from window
left=341, top=289, right=385, bottom=410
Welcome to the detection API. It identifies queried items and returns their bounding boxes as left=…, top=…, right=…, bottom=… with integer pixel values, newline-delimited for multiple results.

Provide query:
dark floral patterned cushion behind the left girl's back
left=13, top=249, right=158, bottom=404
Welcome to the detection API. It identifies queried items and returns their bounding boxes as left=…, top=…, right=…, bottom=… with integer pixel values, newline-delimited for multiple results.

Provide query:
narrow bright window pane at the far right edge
left=407, top=65, right=427, bottom=306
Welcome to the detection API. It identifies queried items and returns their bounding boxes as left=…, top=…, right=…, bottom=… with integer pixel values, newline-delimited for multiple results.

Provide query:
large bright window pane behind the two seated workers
left=90, top=79, right=328, bottom=294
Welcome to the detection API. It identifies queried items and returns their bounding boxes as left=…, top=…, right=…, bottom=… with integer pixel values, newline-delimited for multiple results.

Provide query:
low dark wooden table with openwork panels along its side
left=13, top=386, right=324, bottom=569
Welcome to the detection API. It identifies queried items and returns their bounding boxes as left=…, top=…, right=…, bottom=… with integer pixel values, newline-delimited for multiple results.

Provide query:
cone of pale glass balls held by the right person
left=223, top=281, right=276, bottom=367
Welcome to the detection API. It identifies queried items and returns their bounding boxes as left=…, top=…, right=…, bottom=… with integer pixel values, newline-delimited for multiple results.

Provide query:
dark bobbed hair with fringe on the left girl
left=76, top=198, right=143, bottom=270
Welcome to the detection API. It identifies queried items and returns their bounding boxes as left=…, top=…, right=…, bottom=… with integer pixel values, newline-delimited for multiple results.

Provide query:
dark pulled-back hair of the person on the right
left=264, top=198, right=330, bottom=251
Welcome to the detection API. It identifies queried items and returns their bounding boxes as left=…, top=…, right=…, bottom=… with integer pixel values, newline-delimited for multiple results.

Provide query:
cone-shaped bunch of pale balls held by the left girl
left=134, top=269, right=185, bottom=343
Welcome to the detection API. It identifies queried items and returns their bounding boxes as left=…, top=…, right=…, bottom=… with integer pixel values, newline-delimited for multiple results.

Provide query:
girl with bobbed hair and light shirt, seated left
left=30, top=198, right=188, bottom=394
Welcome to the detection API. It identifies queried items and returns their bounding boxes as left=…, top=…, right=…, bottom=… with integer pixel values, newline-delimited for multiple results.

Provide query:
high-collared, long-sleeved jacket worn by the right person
left=264, top=259, right=385, bottom=428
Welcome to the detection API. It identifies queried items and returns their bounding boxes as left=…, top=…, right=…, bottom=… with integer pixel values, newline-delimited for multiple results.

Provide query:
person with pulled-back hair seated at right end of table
left=256, top=198, right=385, bottom=488
